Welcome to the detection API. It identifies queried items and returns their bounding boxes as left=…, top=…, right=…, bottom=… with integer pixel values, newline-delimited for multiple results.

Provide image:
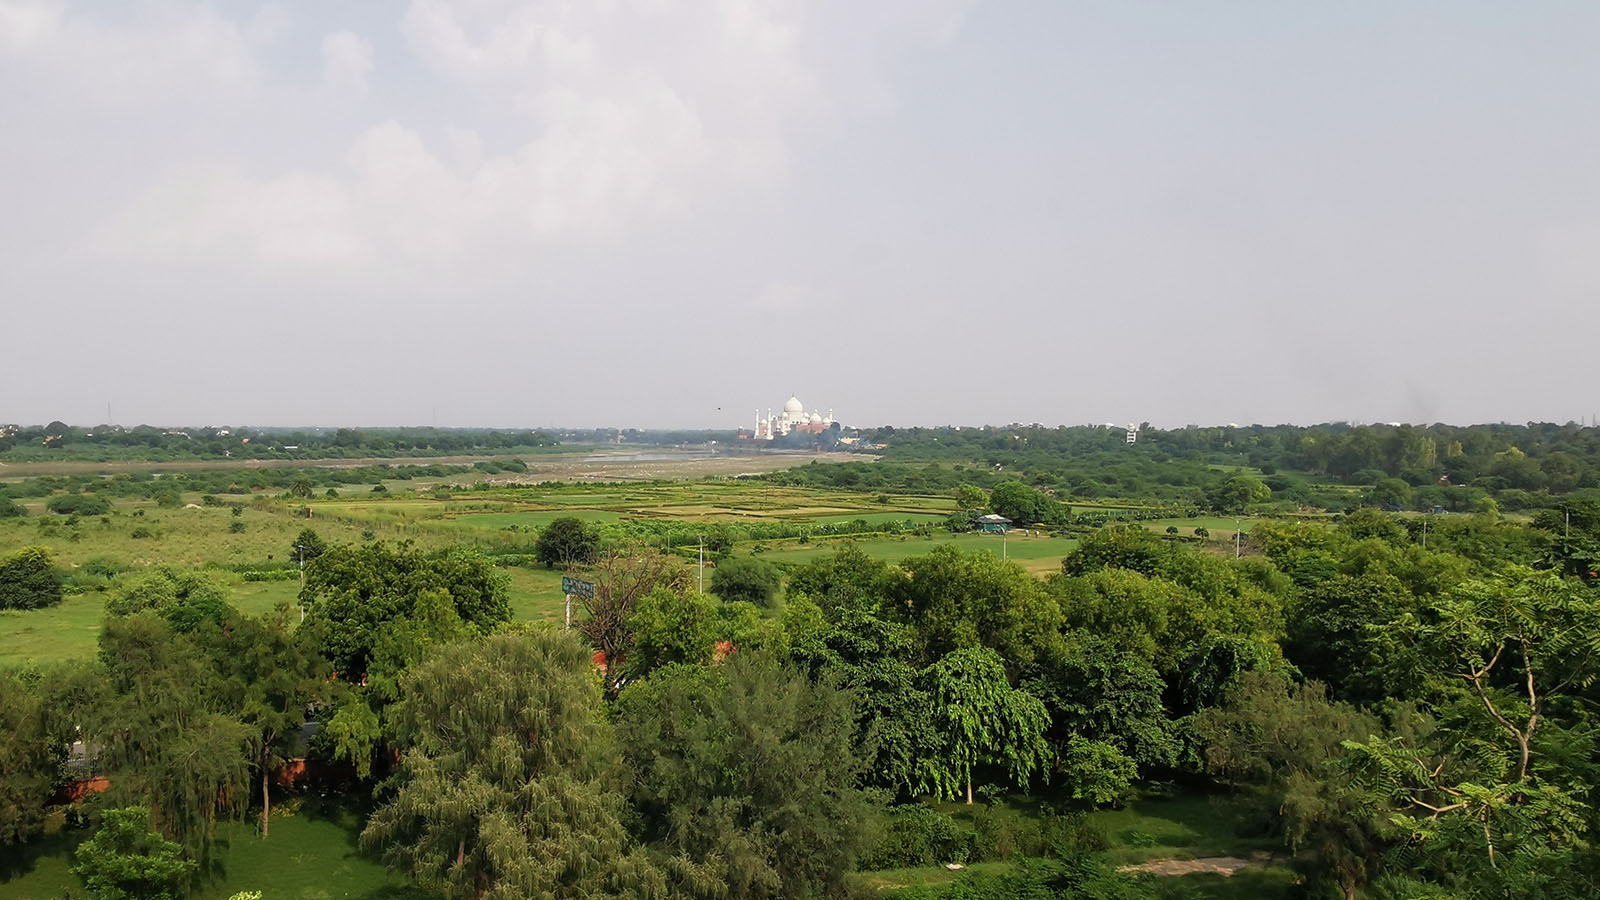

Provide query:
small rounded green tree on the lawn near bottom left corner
left=72, top=806, right=197, bottom=900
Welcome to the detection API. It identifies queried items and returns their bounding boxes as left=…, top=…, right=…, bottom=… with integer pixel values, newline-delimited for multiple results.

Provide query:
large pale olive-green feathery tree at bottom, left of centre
left=362, top=633, right=666, bottom=900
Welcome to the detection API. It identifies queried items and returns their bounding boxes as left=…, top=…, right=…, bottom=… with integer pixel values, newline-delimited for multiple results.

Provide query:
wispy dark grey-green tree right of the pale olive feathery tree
left=616, top=652, right=874, bottom=900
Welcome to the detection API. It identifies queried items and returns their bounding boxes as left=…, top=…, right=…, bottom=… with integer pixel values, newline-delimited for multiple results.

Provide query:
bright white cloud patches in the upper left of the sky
left=68, top=0, right=966, bottom=266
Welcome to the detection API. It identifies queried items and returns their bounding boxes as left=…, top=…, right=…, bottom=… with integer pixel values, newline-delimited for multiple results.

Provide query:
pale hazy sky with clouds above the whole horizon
left=0, top=0, right=1600, bottom=428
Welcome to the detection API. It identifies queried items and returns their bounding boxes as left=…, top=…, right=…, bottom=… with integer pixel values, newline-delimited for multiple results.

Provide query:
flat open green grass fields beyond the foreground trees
left=0, top=480, right=1074, bottom=665
